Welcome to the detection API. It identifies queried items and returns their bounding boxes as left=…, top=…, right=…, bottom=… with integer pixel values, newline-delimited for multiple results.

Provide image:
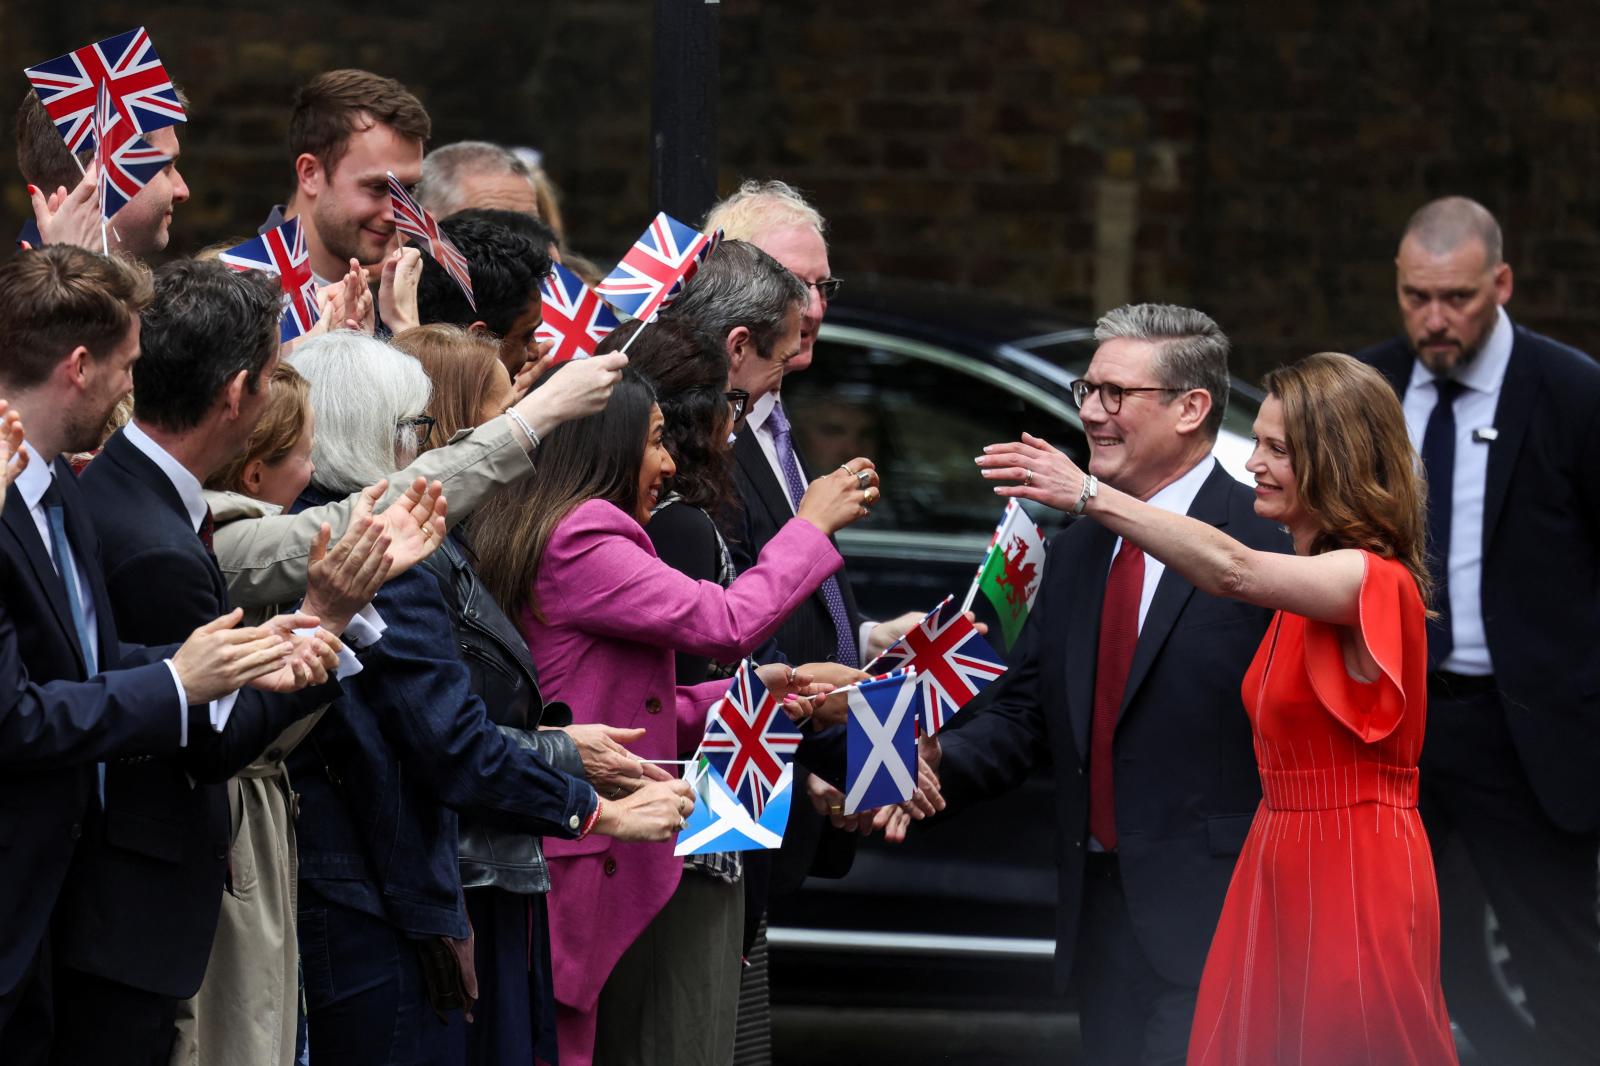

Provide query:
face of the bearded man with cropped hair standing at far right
left=1395, top=237, right=1512, bottom=375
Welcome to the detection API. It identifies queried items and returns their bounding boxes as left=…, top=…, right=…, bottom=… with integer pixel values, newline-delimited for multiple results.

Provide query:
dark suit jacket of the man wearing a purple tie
left=723, top=427, right=861, bottom=892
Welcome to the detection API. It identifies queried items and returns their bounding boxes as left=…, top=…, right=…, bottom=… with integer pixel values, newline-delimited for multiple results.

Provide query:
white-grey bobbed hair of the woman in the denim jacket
left=288, top=330, right=434, bottom=496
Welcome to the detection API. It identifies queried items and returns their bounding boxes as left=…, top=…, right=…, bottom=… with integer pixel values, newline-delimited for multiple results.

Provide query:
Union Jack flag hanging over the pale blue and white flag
left=701, top=661, right=800, bottom=818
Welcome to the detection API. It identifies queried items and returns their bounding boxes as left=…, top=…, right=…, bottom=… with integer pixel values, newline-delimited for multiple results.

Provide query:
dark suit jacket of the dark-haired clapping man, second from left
left=56, top=432, right=339, bottom=999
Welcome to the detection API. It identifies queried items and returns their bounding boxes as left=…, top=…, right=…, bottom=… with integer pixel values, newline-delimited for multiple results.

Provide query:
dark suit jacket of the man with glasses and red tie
left=939, top=461, right=1290, bottom=988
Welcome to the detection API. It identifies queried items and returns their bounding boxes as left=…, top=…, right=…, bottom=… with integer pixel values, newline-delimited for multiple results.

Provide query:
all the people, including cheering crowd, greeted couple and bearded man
left=0, top=60, right=1600, bottom=1066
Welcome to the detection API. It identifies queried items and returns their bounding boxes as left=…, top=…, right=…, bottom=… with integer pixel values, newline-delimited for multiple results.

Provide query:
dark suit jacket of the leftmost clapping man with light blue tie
left=0, top=459, right=205, bottom=994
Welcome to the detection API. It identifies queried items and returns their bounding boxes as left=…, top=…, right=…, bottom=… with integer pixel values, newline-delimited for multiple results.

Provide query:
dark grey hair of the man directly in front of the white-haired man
left=666, top=240, right=811, bottom=359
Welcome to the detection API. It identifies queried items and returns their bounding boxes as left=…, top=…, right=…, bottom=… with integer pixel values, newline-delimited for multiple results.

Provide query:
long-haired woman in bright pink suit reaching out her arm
left=477, top=370, right=878, bottom=1064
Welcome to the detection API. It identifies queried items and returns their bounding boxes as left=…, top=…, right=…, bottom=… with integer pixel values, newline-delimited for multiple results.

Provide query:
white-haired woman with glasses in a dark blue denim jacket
left=290, top=331, right=694, bottom=1064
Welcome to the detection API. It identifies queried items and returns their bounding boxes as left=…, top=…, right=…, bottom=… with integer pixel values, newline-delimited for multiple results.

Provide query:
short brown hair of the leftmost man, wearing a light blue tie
left=0, top=245, right=154, bottom=391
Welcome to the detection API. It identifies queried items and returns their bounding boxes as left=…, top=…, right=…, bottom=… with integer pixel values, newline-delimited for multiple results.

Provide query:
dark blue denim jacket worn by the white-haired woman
left=290, top=493, right=597, bottom=938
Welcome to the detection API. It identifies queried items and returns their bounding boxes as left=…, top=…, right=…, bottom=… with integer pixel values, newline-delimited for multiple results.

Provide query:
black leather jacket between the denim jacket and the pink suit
left=424, top=533, right=584, bottom=895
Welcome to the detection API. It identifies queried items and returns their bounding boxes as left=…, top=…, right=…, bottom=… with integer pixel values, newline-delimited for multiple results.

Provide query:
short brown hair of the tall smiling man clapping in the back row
left=290, top=70, right=434, bottom=173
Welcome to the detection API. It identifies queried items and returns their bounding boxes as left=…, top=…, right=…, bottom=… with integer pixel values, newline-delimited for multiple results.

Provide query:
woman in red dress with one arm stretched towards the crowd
left=979, top=354, right=1456, bottom=1066
